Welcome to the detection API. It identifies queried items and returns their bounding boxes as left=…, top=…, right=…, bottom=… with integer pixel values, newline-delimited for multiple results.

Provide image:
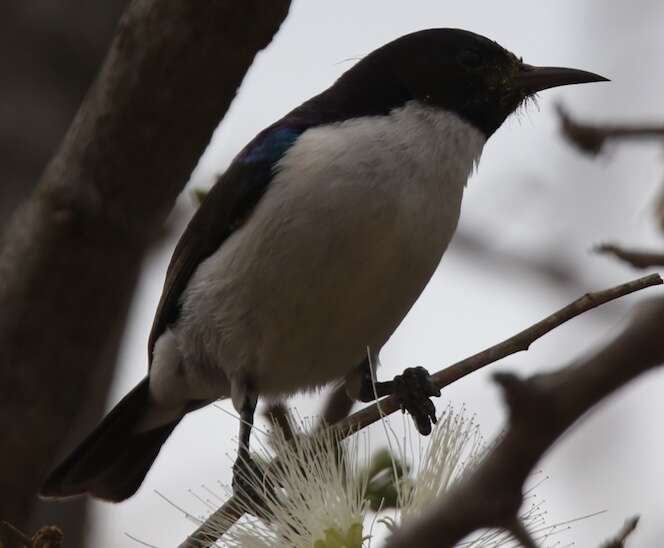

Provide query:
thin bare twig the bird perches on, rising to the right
left=180, top=274, right=663, bottom=548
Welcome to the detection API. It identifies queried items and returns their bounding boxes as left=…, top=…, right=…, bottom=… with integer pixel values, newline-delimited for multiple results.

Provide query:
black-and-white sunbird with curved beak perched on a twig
left=40, top=28, right=607, bottom=502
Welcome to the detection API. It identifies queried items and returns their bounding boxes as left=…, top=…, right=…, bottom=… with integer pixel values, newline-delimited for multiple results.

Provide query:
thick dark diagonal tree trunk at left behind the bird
left=0, top=0, right=289, bottom=528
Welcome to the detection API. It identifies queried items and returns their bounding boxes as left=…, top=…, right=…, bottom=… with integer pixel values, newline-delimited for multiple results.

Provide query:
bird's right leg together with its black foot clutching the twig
left=358, top=359, right=440, bottom=436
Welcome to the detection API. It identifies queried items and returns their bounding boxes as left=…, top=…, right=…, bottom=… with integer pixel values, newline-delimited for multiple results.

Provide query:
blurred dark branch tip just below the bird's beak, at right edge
left=556, top=104, right=664, bottom=155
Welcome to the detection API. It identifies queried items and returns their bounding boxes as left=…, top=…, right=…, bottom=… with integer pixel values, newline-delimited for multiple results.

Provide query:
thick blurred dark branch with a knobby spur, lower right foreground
left=386, top=297, right=664, bottom=548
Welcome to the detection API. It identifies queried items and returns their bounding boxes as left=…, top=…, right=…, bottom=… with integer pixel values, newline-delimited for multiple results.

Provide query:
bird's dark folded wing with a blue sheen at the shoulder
left=148, top=122, right=305, bottom=363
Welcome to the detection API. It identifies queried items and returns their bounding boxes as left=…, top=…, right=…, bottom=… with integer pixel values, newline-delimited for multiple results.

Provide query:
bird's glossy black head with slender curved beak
left=326, top=29, right=606, bottom=136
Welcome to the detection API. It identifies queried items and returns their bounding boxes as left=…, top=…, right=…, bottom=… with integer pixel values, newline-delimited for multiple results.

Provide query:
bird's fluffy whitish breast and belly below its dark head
left=153, top=102, right=485, bottom=406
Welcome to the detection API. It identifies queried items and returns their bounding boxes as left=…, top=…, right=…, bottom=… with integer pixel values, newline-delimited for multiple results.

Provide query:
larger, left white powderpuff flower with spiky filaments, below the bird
left=209, top=418, right=367, bottom=548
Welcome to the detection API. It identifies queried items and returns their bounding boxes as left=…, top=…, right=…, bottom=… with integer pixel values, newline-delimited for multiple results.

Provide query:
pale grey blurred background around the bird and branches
left=93, top=0, right=664, bottom=548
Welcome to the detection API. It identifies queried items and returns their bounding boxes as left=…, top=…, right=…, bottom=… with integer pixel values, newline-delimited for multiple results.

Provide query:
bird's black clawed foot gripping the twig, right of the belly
left=392, top=367, right=440, bottom=436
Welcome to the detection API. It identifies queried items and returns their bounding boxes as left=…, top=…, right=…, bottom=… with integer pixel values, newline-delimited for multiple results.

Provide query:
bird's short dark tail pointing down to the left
left=40, top=378, right=180, bottom=502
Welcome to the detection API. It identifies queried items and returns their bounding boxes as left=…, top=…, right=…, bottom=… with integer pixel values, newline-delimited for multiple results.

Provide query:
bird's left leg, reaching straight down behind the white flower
left=233, top=388, right=269, bottom=519
